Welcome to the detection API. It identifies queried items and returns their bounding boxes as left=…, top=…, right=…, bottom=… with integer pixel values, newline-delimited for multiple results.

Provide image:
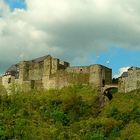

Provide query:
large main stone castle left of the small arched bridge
left=2, top=55, right=112, bottom=90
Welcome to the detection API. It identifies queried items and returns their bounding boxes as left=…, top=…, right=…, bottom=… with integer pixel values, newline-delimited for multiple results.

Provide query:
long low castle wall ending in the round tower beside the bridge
left=43, top=65, right=112, bottom=89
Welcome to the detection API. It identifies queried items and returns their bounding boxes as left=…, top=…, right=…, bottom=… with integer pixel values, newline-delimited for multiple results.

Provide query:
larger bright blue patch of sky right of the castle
left=97, top=47, right=140, bottom=75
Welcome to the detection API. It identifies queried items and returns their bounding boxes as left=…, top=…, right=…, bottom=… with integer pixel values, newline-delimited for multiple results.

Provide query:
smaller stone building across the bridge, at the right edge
left=118, top=67, right=140, bottom=93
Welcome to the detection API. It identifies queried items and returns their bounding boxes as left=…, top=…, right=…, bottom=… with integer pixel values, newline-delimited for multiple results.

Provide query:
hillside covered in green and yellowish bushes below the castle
left=0, top=86, right=140, bottom=140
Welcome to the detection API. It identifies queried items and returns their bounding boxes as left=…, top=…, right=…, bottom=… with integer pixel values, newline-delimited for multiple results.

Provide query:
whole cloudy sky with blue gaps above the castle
left=0, top=0, right=140, bottom=77
